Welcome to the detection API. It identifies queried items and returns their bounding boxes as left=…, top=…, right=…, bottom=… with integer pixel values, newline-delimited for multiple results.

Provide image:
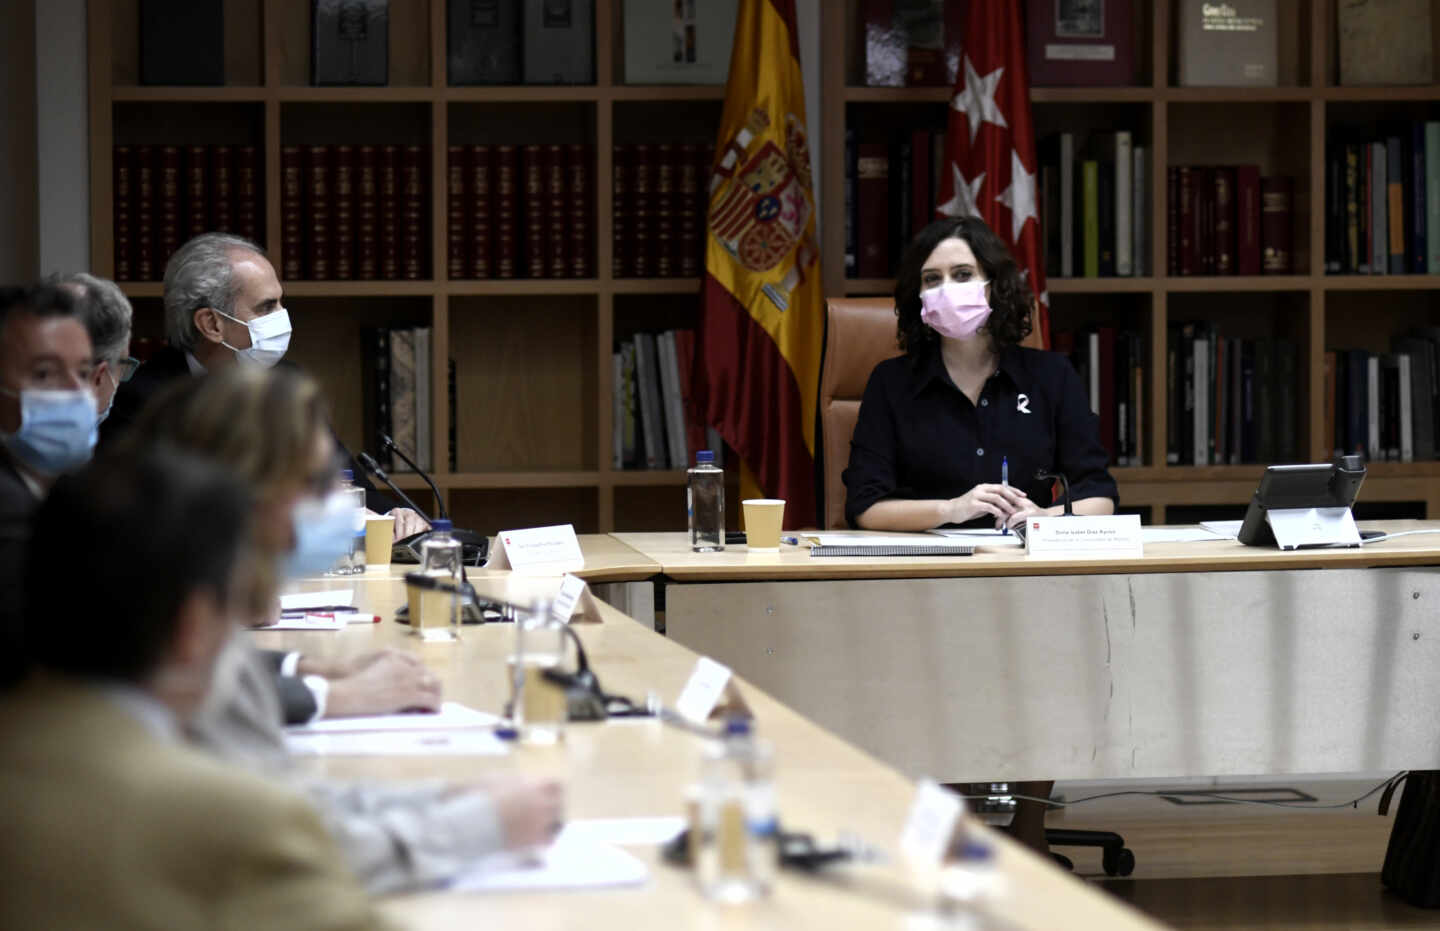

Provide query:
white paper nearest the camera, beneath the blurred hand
left=451, top=832, right=649, bottom=892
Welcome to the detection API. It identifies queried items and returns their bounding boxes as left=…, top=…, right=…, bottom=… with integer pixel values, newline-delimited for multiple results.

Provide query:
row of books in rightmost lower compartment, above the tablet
left=1323, top=335, right=1440, bottom=462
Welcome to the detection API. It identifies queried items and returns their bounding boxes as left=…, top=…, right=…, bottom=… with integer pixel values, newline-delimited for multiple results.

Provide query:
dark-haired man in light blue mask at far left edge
left=0, top=285, right=95, bottom=678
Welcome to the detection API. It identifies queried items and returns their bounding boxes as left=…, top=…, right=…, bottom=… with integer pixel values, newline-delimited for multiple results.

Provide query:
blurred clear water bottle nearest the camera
left=691, top=718, right=779, bottom=902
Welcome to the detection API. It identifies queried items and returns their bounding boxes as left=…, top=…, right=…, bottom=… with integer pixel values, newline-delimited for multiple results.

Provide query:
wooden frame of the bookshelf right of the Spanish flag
left=818, top=0, right=1440, bottom=522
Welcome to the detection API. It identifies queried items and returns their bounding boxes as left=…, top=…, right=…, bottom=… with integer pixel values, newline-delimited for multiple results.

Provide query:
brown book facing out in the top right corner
left=1335, top=0, right=1434, bottom=86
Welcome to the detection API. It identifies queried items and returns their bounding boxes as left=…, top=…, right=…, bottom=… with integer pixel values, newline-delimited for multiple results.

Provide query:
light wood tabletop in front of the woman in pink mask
left=613, top=521, right=1440, bottom=581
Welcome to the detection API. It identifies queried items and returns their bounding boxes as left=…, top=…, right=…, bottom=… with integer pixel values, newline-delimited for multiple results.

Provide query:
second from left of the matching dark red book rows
left=279, top=145, right=431, bottom=281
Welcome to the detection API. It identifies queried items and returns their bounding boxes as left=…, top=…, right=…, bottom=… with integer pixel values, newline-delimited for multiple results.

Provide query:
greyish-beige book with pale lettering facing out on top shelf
left=1175, top=0, right=1279, bottom=88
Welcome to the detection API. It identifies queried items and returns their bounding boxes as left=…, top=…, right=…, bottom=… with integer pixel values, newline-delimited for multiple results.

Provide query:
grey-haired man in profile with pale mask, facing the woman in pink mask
left=101, top=233, right=429, bottom=540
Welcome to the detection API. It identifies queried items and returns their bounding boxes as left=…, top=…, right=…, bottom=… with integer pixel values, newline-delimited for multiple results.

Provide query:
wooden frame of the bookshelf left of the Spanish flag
left=88, top=0, right=739, bottom=532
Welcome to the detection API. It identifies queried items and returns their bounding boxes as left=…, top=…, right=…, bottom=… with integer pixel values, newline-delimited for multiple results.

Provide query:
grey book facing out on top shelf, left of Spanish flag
left=624, top=0, right=739, bottom=83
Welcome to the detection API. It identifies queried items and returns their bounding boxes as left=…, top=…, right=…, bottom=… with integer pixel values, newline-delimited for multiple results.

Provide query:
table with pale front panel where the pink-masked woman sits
left=615, top=521, right=1440, bottom=781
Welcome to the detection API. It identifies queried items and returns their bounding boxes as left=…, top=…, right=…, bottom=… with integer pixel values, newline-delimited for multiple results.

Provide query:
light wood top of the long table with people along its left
left=252, top=576, right=1159, bottom=931
